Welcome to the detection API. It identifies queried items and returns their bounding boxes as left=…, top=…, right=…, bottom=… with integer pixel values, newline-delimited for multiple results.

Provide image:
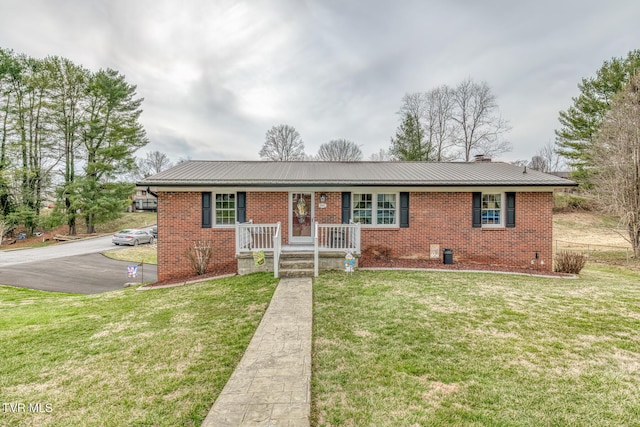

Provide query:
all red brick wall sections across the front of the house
left=158, top=192, right=553, bottom=280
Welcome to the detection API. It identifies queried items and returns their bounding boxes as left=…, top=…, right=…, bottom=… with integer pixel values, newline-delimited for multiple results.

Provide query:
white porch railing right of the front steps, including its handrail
left=313, top=222, right=360, bottom=277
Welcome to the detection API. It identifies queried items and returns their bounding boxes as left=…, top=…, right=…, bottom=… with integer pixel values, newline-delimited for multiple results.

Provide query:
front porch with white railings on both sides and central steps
left=235, top=221, right=360, bottom=277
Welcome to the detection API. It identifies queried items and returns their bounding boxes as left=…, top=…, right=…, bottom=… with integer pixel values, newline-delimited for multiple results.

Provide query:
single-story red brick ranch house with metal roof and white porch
left=138, top=159, right=575, bottom=281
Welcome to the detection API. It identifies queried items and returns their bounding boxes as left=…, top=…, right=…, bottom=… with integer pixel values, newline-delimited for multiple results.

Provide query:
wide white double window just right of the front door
left=352, top=193, right=398, bottom=226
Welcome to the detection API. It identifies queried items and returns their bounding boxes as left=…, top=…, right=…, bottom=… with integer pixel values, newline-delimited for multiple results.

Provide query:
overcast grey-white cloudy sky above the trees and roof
left=0, top=0, right=640, bottom=165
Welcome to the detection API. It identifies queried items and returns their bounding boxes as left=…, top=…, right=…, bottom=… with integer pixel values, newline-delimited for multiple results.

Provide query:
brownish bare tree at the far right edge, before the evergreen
left=590, top=75, right=640, bottom=259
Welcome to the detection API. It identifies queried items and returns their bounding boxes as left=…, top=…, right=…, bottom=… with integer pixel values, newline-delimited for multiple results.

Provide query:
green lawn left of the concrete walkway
left=0, top=274, right=276, bottom=426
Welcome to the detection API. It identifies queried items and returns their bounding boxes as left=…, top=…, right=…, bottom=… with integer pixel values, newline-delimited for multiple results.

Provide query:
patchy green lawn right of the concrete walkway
left=312, top=266, right=640, bottom=426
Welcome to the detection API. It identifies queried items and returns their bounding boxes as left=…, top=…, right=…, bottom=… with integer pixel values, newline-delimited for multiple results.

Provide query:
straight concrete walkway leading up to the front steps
left=202, top=278, right=312, bottom=427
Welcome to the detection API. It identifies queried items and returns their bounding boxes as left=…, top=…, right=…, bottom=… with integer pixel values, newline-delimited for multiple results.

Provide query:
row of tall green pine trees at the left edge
left=0, top=49, right=148, bottom=234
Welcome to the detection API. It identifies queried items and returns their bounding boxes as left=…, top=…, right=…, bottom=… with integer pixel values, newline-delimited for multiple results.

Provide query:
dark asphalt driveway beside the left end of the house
left=0, top=251, right=158, bottom=294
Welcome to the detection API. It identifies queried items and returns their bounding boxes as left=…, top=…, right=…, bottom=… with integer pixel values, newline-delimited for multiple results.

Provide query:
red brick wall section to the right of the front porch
left=360, top=193, right=553, bottom=271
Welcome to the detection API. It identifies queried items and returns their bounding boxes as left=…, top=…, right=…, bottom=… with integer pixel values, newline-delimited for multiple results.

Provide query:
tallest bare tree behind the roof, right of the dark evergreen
left=452, top=78, right=511, bottom=162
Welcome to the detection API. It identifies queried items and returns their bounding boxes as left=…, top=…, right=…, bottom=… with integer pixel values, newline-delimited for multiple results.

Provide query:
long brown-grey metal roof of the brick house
left=139, top=160, right=575, bottom=187
